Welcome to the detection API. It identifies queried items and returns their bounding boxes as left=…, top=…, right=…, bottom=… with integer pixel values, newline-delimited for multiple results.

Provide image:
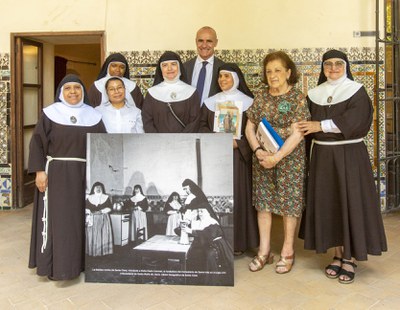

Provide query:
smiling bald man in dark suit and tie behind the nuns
left=183, top=26, right=224, bottom=104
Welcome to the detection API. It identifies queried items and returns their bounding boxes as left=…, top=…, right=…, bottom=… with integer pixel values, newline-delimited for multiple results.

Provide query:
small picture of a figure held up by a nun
left=213, top=101, right=243, bottom=139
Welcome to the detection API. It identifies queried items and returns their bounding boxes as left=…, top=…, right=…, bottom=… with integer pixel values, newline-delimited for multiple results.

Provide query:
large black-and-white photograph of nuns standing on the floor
left=85, top=133, right=234, bottom=286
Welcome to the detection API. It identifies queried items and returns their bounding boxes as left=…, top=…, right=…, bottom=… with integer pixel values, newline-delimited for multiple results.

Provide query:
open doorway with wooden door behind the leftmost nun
left=10, top=31, right=105, bottom=208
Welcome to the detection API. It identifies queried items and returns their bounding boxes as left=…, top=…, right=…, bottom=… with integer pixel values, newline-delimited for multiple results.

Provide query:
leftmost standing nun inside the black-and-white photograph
left=86, top=182, right=113, bottom=256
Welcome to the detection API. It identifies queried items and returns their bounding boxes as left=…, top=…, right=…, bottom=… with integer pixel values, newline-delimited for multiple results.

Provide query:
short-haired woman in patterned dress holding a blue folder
left=246, top=51, right=310, bottom=274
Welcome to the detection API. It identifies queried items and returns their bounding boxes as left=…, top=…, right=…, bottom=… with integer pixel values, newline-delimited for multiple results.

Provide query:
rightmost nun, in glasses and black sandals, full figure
left=299, top=50, right=387, bottom=284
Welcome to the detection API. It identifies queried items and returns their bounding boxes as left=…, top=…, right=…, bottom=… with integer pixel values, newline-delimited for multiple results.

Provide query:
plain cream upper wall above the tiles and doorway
left=0, top=0, right=383, bottom=52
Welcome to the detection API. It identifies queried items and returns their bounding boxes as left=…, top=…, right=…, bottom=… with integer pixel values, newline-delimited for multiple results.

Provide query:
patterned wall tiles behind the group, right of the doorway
left=121, top=47, right=386, bottom=175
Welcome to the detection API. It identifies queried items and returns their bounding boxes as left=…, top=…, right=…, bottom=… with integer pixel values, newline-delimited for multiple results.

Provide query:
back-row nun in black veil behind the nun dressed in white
left=88, top=53, right=143, bottom=109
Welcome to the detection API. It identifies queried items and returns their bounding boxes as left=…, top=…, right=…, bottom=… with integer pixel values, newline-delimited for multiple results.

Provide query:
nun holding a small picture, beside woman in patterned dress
left=199, top=63, right=259, bottom=255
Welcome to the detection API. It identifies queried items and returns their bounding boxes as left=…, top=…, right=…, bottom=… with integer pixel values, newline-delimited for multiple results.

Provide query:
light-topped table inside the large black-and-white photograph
left=133, top=235, right=190, bottom=271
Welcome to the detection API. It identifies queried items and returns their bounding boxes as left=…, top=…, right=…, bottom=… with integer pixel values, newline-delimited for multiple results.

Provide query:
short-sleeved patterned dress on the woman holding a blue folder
left=246, top=86, right=310, bottom=217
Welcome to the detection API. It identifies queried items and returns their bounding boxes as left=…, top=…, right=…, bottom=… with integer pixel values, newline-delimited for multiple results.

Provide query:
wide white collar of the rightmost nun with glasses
left=308, top=77, right=362, bottom=105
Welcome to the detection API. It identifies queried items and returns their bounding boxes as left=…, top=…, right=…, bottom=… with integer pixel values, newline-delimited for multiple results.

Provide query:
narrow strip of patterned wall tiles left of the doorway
left=0, top=53, right=12, bottom=210
